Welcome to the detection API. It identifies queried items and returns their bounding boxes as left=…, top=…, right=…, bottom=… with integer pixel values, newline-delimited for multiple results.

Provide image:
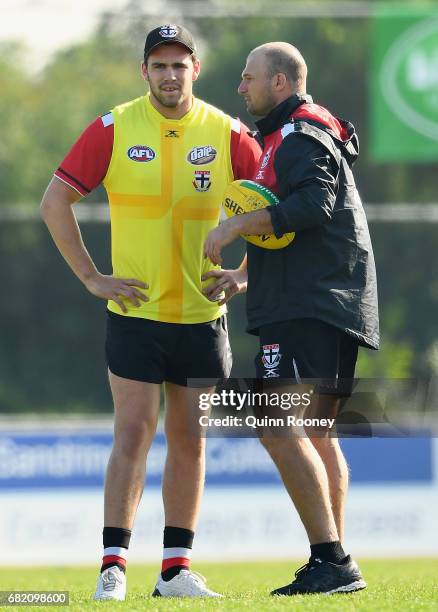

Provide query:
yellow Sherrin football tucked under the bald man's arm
left=222, top=180, right=295, bottom=249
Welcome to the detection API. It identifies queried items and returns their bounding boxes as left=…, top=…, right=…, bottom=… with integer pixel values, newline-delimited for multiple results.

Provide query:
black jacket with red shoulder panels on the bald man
left=247, top=91, right=379, bottom=349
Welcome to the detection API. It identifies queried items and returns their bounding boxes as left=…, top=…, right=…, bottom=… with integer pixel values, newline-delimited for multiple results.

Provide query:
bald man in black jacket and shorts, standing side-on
left=205, top=43, right=379, bottom=595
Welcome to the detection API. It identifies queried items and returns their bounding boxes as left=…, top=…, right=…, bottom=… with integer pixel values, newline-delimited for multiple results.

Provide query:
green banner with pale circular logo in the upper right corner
left=369, top=4, right=438, bottom=162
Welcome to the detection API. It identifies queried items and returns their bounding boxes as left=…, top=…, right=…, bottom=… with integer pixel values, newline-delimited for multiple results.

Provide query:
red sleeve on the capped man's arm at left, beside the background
left=55, top=113, right=114, bottom=196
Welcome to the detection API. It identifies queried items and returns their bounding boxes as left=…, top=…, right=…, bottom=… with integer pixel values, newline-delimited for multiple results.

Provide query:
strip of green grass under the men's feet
left=0, top=559, right=438, bottom=612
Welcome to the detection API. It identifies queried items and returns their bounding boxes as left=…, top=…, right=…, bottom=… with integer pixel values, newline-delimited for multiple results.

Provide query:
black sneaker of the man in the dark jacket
left=271, top=555, right=367, bottom=595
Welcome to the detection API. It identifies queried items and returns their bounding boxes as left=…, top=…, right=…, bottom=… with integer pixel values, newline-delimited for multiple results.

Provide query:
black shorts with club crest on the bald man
left=255, top=319, right=358, bottom=397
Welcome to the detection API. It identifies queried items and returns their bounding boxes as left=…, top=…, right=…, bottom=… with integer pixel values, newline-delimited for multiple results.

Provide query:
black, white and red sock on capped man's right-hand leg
left=161, top=527, right=195, bottom=582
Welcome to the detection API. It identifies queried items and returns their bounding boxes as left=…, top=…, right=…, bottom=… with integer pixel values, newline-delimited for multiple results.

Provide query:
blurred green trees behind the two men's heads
left=0, top=2, right=435, bottom=205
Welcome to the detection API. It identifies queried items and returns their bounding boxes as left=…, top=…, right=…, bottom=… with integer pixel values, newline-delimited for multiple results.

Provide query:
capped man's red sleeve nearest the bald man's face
left=231, top=119, right=262, bottom=180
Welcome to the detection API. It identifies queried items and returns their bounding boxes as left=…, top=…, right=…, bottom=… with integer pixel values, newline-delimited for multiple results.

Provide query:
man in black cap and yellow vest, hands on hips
left=41, top=24, right=260, bottom=600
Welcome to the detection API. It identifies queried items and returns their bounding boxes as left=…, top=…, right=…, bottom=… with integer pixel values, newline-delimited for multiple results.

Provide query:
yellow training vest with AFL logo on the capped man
left=103, top=95, right=233, bottom=323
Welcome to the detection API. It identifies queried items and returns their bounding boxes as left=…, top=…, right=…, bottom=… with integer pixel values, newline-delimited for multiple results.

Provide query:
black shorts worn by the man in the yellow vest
left=105, top=311, right=232, bottom=387
